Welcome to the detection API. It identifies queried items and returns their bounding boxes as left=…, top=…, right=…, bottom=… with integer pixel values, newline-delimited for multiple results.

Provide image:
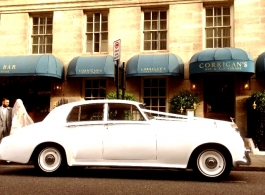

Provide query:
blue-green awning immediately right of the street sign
left=126, top=54, right=184, bottom=77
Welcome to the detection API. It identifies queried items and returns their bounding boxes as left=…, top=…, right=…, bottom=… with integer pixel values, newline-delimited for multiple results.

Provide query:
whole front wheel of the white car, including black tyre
left=193, top=149, right=231, bottom=181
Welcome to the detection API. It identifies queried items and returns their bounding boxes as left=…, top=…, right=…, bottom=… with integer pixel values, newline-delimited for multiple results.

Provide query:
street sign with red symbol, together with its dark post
left=113, top=39, right=121, bottom=99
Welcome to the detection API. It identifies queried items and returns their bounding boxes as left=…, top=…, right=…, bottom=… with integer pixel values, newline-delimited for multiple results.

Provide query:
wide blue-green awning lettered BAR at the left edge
left=0, top=54, right=63, bottom=79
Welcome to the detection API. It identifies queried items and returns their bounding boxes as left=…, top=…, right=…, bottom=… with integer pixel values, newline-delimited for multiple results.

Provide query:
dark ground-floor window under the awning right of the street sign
left=144, top=78, right=166, bottom=112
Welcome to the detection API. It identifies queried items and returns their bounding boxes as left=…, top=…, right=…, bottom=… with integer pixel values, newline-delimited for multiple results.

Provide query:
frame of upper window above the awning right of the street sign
left=141, top=7, right=169, bottom=52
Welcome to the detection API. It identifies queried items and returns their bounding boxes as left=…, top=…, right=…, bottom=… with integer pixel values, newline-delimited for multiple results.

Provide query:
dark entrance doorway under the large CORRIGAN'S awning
left=204, top=75, right=235, bottom=121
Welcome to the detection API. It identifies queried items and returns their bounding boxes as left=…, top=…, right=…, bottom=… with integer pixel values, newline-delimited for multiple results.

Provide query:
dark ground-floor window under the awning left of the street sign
left=85, top=79, right=106, bottom=100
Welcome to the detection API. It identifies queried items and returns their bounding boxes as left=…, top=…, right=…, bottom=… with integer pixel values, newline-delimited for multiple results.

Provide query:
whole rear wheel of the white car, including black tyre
left=34, top=146, right=66, bottom=174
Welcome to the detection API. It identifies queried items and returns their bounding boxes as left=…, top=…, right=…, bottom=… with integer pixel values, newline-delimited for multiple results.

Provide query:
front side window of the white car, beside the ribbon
left=108, top=103, right=145, bottom=121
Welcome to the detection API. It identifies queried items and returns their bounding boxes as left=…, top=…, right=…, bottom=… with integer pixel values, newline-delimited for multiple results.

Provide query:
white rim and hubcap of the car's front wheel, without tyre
left=197, top=150, right=226, bottom=177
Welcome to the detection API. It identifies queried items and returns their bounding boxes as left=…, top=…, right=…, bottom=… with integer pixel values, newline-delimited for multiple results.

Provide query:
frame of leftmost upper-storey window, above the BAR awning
left=29, top=13, right=54, bottom=55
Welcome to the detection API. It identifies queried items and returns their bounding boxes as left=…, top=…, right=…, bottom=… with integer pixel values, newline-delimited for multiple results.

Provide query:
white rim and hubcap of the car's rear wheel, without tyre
left=38, top=148, right=62, bottom=172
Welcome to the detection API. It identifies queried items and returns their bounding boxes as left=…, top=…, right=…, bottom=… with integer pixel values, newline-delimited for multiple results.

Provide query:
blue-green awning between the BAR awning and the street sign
left=67, top=55, right=114, bottom=77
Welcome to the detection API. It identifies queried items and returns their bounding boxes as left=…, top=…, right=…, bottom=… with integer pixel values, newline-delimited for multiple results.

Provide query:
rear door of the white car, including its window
left=67, top=103, right=105, bottom=162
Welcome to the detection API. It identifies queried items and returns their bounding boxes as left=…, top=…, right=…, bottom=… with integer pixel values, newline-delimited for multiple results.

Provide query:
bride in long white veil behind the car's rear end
left=10, top=99, right=34, bottom=134
